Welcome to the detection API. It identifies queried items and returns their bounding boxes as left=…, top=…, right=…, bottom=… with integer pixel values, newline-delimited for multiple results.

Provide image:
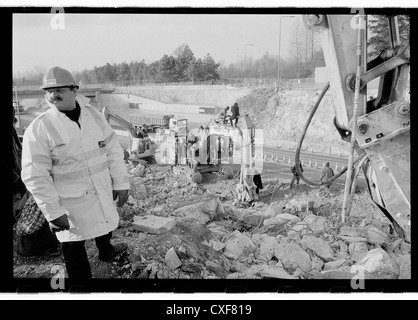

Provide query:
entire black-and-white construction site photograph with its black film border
left=10, top=1, right=414, bottom=298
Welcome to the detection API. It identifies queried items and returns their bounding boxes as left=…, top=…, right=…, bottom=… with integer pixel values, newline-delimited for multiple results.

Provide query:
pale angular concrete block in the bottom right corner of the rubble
left=355, top=248, right=399, bottom=279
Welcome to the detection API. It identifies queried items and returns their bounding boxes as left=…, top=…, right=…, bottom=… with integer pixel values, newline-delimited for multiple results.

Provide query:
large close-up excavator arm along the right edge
left=303, top=14, right=411, bottom=240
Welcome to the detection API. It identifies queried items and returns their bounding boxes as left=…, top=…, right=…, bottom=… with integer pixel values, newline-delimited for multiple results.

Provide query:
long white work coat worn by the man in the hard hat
left=22, top=95, right=130, bottom=242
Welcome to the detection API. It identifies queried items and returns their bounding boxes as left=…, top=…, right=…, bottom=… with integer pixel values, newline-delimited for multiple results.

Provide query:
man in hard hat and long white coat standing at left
left=22, top=67, right=130, bottom=280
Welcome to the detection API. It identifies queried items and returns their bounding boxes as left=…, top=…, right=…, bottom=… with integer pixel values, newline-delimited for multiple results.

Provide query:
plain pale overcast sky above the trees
left=13, top=14, right=300, bottom=73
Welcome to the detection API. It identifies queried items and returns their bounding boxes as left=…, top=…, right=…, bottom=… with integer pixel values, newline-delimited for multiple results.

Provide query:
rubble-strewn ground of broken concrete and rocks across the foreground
left=14, top=163, right=411, bottom=279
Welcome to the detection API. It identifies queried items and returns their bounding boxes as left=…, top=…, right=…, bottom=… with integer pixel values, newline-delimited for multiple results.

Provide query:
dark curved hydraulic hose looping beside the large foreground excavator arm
left=295, top=82, right=364, bottom=187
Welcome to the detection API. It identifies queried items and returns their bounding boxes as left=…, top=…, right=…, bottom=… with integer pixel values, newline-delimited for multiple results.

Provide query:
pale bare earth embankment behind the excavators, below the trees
left=126, top=86, right=347, bottom=147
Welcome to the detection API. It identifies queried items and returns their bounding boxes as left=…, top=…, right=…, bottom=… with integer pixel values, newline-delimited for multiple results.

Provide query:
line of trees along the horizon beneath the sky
left=14, top=15, right=410, bottom=86
